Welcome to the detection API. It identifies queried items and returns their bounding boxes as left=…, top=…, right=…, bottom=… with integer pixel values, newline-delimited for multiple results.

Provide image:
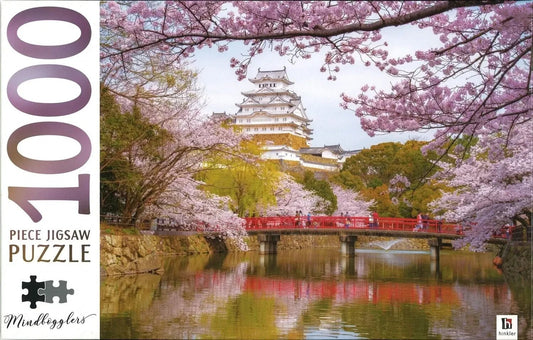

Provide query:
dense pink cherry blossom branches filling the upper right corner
left=343, top=3, right=533, bottom=155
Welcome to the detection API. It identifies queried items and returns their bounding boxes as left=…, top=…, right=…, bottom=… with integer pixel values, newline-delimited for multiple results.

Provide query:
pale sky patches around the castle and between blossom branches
left=192, top=26, right=438, bottom=150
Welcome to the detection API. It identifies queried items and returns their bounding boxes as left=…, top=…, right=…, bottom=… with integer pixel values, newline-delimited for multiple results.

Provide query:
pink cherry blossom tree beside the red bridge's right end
left=432, top=122, right=533, bottom=249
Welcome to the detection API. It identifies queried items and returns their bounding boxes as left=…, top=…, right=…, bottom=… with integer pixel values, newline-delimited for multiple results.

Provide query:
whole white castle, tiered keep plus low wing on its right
left=220, top=68, right=358, bottom=171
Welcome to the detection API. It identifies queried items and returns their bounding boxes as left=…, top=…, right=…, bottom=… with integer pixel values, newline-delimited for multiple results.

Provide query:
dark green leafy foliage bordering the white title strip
left=100, top=87, right=172, bottom=223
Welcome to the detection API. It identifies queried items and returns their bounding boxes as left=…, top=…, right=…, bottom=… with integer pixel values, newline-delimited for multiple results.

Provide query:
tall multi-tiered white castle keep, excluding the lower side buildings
left=234, top=67, right=312, bottom=160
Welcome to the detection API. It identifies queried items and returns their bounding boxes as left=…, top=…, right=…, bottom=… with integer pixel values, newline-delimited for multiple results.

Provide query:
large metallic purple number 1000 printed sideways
left=7, top=7, right=91, bottom=222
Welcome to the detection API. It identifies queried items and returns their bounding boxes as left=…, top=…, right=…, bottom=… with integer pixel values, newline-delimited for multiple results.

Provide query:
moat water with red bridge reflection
left=101, top=248, right=531, bottom=339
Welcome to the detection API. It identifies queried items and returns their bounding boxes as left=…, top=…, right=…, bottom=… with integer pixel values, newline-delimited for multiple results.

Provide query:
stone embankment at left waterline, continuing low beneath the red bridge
left=100, top=234, right=428, bottom=275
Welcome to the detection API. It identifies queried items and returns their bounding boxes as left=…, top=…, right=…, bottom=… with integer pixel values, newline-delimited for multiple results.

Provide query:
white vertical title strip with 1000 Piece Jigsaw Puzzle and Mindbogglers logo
left=0, top=1, right=100, bottom=339
